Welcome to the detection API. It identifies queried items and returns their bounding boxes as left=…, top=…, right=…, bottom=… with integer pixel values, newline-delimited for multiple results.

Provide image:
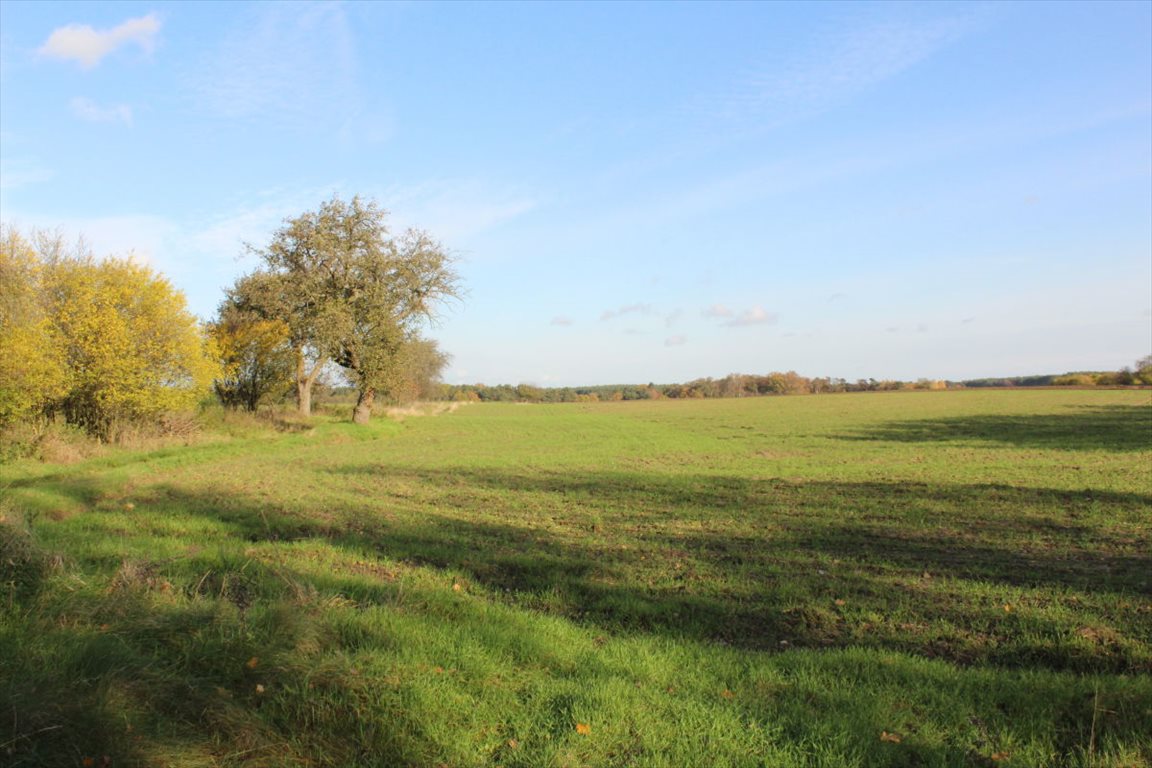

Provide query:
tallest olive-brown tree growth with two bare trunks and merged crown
left=244, top=197, right=458, bottom=424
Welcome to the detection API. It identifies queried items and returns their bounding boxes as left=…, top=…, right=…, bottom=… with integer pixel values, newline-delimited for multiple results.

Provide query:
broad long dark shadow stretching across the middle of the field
left=33, top=466, right=1152, bottom=671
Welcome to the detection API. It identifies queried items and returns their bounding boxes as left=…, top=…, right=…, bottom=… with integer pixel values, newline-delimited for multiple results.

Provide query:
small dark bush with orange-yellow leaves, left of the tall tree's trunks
left=209, top=297, right=296, bottom=411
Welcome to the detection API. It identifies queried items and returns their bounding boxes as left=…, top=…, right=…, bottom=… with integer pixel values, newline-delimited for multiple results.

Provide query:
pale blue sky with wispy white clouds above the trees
left=0, top=0, right=1152, bottom=386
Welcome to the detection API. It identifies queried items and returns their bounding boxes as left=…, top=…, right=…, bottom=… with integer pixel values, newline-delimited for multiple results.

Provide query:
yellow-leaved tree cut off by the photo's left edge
left=0, top=228, right=68, bottom=426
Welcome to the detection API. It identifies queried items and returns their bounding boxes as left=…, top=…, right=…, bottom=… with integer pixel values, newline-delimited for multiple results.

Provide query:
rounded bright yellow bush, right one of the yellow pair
left=44, top=257, right=217, bottom=439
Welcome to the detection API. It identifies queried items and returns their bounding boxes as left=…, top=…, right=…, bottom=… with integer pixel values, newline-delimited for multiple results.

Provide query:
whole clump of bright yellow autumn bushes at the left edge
left=0, top=222, right=217, bottom=439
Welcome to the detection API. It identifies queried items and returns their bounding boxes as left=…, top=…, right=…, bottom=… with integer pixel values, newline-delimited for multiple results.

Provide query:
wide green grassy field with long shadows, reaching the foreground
left=0, top=390, right=1152, bottom=768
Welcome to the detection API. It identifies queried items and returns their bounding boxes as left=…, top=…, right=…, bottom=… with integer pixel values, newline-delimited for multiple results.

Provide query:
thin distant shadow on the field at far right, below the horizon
left=840, top=405, right=1152, bottom=451
